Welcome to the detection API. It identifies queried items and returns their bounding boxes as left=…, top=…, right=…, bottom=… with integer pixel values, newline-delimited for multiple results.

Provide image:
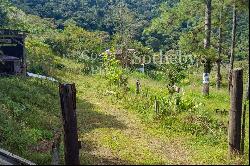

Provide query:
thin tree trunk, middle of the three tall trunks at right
left=216, top=0, right=224, bottom=90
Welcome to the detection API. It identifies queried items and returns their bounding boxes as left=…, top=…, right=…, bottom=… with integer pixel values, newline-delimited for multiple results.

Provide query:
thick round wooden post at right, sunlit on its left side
left=228, top=69, right=243, bottom=156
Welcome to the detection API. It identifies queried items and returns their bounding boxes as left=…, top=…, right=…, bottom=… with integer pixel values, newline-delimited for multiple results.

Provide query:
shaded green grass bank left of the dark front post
left=0, top=77, right=61, bottom=164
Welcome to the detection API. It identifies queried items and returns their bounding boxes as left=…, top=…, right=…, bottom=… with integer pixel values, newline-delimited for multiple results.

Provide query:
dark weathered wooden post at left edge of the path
left=59, top=84, right=80, bottom=165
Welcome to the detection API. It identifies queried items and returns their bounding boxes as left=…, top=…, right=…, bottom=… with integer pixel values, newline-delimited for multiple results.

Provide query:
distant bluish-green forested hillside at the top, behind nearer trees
left=11, top=0, right=166, bottom=37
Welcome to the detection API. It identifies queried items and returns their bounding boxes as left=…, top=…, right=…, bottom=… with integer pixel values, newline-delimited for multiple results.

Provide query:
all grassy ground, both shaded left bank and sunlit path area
left=0, top=58, right=249, bottom=164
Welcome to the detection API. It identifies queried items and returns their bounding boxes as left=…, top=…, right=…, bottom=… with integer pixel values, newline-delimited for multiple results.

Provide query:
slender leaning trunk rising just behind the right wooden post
left=228, top=0, right=237, bottom=92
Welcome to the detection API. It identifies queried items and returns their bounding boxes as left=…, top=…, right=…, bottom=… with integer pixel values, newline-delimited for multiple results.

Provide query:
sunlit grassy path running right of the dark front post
left=75, top=79, right=188, bottom=164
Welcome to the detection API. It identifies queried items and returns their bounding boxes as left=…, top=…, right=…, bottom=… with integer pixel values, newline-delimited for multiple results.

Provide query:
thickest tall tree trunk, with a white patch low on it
left=203, top=0, right=212, bottom=95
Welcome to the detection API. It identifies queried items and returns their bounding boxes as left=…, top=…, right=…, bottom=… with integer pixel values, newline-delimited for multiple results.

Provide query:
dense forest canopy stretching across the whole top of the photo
left=0, top=0, right=249, bottom=74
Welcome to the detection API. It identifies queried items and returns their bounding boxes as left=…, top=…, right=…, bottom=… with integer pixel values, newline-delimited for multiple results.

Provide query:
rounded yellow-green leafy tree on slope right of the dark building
left=45, top=23, right=107, bottom=59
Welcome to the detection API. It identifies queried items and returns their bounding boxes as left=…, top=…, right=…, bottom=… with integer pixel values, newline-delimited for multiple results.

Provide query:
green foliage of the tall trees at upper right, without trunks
left=143, top=0, right=249, bottom=58
